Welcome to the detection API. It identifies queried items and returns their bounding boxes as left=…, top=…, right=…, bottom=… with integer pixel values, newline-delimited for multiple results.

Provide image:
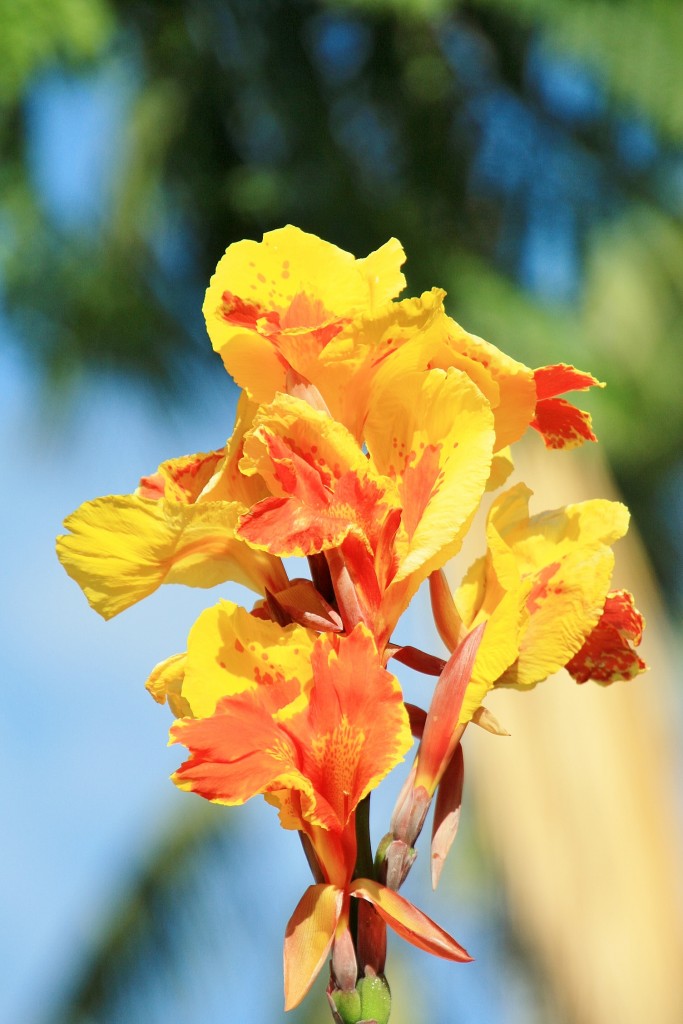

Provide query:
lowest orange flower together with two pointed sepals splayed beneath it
left=171, top=610, right=469, bottom=1009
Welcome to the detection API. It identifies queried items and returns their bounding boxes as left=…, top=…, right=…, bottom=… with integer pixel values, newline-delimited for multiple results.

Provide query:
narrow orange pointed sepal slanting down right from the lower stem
left=349, top=879, right=472, bottom=964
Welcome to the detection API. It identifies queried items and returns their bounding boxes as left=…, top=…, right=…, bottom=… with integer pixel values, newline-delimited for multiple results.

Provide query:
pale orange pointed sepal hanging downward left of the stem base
left=285, top=885, right=343, bottom=1010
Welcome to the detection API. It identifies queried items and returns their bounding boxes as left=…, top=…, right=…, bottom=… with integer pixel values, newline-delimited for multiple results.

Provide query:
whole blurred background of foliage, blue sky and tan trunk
left=5, top=0, right=683, bottom=1024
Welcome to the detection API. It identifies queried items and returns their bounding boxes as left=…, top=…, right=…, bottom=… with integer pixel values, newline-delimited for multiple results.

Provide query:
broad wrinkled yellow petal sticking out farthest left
left=57, top=495, right=287, bottom=618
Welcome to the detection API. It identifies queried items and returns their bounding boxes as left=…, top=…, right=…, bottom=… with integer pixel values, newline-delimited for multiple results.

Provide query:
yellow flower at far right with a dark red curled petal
left=432, top=484, right=644, bottom=722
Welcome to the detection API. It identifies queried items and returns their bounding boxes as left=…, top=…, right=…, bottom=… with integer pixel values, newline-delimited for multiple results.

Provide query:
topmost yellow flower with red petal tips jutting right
left=204, top=232, right=603, bottom=460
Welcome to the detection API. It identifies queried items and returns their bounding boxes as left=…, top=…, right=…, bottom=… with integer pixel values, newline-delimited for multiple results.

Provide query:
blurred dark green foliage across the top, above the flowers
left=0, top=0, right=683, bottom=575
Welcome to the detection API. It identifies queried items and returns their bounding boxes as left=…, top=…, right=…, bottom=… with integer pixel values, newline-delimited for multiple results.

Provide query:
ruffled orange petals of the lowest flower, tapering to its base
left=171, top=624, right=412, bottom=886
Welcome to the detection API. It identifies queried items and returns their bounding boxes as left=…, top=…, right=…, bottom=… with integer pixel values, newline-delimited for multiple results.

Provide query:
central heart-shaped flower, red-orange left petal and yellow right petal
left=238, top=370, right=494, bottom=649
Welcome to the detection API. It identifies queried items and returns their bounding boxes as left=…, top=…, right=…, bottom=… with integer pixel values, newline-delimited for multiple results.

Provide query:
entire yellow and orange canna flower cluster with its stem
left=57, top=226, right=645, bottom=1022
